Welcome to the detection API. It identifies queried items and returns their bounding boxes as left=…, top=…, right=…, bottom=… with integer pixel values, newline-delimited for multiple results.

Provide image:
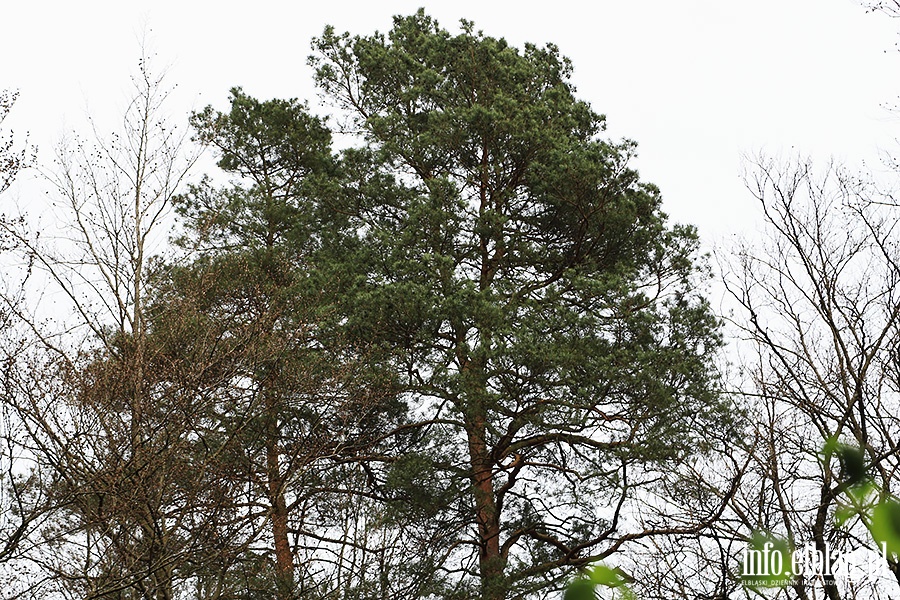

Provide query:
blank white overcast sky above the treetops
left=0, top=0, right=900, bottom=242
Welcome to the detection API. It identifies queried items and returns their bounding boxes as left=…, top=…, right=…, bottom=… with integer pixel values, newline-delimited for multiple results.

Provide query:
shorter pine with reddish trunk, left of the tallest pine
left=162, top=89, right=402, bottom=599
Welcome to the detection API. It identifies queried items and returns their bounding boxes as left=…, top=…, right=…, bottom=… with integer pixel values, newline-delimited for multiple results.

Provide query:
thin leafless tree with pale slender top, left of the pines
left=3, top=52, right=250, bottom=599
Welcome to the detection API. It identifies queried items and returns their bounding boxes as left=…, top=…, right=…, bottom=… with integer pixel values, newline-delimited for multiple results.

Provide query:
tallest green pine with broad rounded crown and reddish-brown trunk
left=312, top=11, right=724, bottom=598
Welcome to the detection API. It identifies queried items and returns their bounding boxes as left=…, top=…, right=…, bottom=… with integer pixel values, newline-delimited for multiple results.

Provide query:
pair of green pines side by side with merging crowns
left=51, top=11, right=727, bottom=600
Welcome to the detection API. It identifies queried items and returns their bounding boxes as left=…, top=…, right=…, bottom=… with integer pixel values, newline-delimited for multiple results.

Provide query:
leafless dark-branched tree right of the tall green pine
left=726, top=159, right=900, bottom=600
